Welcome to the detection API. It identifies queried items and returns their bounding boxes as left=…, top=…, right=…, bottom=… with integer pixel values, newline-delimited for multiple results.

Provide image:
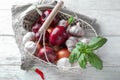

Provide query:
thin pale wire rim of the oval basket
left=20, top=5, right=98, bottom=69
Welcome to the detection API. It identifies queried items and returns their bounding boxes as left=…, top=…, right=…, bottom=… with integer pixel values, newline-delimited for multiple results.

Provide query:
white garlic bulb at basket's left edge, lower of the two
left=24, top=41, right=36, bottom=54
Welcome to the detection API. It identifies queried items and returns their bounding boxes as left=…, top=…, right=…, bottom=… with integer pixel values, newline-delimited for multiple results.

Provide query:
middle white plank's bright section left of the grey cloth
left=0, top=36, right=21, bottom=65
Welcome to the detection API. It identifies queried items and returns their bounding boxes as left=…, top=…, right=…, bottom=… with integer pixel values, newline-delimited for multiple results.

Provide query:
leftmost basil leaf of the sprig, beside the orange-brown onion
left=69, top=48, right=81, bottom=63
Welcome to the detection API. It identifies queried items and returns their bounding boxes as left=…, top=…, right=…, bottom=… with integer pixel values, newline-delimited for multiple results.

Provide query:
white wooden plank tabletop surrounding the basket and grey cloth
left=0, top=0, right=120, bottom=80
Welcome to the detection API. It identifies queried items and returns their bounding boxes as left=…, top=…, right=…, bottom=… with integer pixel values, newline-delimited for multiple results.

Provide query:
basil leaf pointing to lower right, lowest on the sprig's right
left=88, top=53, right=103, bottom=70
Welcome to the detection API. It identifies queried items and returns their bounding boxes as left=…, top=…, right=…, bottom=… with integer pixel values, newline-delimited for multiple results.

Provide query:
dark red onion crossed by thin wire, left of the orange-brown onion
left=37, top=47, right=56, bottom=63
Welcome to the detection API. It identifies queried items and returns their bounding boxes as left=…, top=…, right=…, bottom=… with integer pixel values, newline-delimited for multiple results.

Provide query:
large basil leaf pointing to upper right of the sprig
left=88, top=36, right=107, bottom=50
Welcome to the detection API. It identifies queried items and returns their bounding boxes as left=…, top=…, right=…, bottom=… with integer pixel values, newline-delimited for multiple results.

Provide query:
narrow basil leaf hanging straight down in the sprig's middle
left=78, top=53, right=87, bottom=68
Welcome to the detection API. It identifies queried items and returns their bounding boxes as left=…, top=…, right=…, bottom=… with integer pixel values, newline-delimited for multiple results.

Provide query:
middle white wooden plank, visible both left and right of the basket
left=0, top=36, right=120, bottom=66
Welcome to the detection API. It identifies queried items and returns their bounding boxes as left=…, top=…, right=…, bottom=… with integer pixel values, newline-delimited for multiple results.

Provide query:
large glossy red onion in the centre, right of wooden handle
left=49, top=26, right=68, bottom=46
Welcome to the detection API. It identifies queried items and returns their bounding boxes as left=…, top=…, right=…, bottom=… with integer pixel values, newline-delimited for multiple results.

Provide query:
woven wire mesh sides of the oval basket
left=11, top=1, right=97, bottom=75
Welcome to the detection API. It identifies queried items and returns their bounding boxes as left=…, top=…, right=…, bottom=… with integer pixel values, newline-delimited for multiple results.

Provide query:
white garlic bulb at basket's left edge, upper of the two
left=22, top=32, right=35, bottom=44
